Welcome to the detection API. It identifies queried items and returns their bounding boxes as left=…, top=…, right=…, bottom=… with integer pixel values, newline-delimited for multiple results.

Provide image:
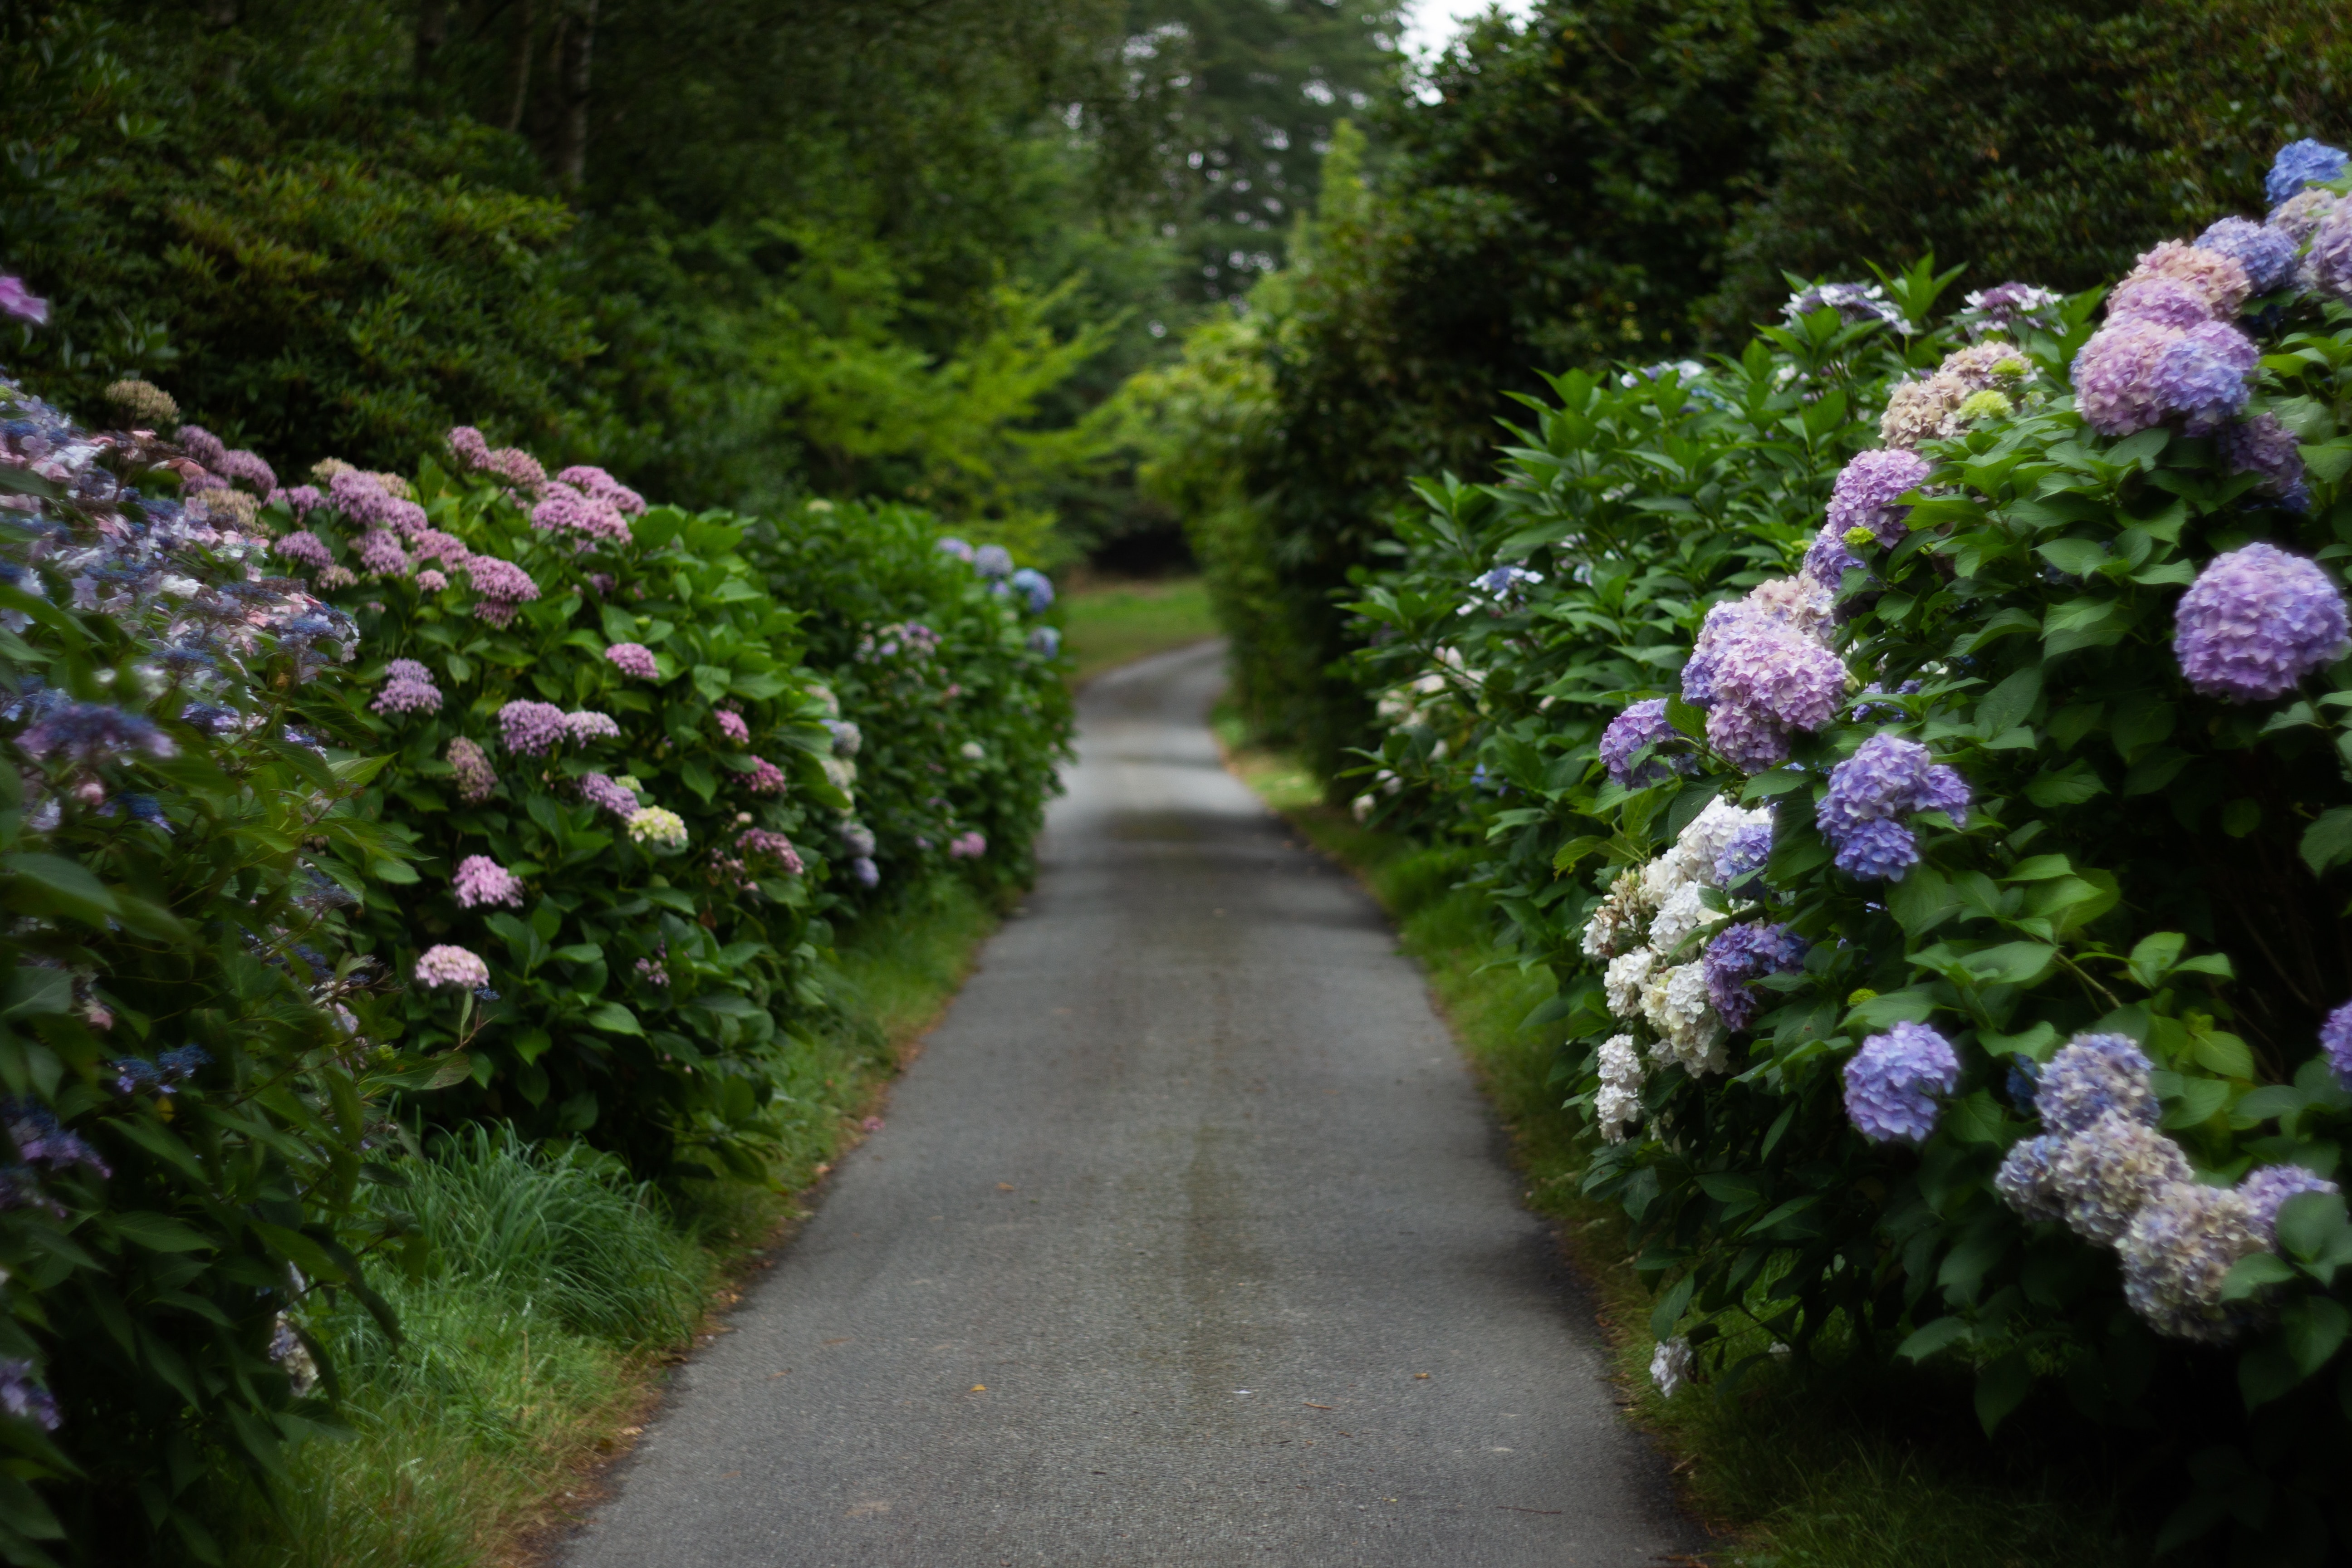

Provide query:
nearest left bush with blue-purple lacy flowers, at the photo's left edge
left=0, top=386, right=431, bottom=1563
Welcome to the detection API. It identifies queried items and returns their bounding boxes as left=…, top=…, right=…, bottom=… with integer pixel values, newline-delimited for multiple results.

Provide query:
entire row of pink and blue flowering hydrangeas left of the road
left=0, top=280, right=1068, bottom=1563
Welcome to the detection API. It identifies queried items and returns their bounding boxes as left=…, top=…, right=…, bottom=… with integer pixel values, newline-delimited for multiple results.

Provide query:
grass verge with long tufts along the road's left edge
left=219, top=879, right=997, bottom=1568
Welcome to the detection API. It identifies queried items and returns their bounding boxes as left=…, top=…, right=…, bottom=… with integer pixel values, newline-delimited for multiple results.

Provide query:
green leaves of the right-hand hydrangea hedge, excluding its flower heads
left=1359, top=245, right=2352, bottom=1563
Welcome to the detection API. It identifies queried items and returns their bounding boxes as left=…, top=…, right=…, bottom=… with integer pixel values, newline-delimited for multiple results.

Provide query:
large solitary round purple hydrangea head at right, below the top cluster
left=2173, top=541, right=2352, bottom=703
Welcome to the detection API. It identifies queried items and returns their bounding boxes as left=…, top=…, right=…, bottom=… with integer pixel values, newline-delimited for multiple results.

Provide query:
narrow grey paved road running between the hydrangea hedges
left=567, top=647, right=1700, bottom=1568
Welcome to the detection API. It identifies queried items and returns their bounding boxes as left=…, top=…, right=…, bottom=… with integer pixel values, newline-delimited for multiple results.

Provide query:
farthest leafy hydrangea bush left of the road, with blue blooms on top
left=743, top=501, right=1070, bottom=900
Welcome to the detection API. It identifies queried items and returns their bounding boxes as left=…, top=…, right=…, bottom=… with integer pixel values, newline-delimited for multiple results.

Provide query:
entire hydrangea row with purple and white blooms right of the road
left=1357, top=143, right=2352, bottom=1561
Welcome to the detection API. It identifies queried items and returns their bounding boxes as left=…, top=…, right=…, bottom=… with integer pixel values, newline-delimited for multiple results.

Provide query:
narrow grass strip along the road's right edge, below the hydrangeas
left=1218, top=717, right=2161, bottom=1568
